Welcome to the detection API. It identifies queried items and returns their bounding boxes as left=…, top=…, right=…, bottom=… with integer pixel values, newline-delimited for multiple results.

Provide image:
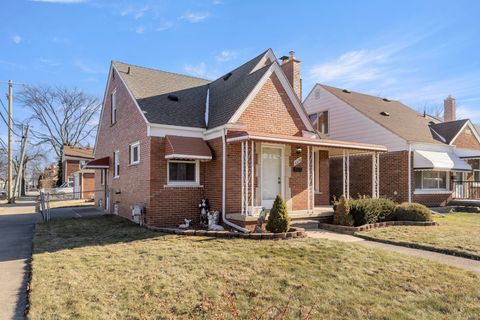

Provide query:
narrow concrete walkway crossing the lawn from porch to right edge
left=307, top=229, right=480, bottom=272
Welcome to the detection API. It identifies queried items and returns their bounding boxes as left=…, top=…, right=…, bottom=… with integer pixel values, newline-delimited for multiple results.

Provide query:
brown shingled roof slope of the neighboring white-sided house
left=319, top=84, right=444, bottom=144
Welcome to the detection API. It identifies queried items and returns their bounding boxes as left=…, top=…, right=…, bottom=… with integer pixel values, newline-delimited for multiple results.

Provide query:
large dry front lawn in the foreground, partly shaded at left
left=29, top=217, right=480, bottom=320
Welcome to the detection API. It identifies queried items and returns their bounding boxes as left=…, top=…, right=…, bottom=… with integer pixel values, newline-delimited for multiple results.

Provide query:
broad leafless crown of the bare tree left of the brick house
left=18, top=86, right=100, bottom=157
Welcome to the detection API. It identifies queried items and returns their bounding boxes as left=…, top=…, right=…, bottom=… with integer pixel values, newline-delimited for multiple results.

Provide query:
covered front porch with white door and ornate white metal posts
left=226, top=131, right=385, bottom=226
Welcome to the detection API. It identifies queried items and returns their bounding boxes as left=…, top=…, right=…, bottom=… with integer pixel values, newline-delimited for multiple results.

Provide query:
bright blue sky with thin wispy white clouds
left=0, top=0, right=480, bottom=156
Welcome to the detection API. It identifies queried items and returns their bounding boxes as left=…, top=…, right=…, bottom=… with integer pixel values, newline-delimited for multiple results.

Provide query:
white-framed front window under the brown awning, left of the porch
left=167, top=160, right=200, bottom=185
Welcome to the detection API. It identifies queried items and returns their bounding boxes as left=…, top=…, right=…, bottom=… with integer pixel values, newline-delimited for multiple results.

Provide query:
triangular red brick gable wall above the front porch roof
left=238, top=74, right=306, bottom=136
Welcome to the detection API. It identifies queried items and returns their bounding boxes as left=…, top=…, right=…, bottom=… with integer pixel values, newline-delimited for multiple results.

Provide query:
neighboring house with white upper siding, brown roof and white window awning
left=304, top=84, right=480, bottom=206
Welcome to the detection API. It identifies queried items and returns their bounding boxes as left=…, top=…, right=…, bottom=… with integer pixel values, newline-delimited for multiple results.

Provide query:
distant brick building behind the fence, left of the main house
left=62, top=146, right=95, bottom=199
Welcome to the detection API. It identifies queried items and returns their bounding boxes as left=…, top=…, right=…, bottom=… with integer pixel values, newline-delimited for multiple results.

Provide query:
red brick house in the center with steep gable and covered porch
left=87, top=50, right=386, bottom=231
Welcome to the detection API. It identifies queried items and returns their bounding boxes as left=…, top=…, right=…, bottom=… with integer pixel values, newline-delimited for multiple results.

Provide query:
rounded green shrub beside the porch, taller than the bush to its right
left=350, top=198, right=397, bottom=226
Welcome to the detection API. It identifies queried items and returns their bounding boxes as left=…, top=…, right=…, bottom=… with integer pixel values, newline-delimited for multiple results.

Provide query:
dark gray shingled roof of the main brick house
left=112, top=50, right=268, bottom=128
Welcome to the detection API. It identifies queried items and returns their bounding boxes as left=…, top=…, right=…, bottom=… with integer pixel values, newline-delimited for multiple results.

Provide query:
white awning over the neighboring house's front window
left=413, top=150, right=472, bottom=171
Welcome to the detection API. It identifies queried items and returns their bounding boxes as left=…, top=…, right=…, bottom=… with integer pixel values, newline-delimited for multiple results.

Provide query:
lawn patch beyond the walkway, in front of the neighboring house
left=359, top=213, right=480, bottom=257
